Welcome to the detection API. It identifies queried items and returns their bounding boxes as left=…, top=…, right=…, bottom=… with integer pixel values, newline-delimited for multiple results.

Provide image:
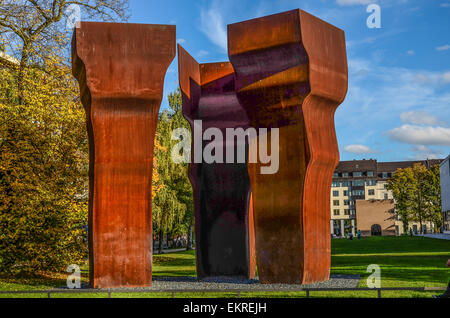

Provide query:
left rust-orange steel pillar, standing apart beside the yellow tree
left=72, top=22, right=175, bottom=288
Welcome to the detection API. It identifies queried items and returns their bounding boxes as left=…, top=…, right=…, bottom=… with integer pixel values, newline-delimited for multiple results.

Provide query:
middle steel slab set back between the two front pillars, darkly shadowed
left=178, top=45, right=255, bottom=279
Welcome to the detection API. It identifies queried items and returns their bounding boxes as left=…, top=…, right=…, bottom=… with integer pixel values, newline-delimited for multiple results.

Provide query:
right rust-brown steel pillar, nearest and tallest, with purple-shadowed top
left=228, top=10, right=347, bottom=283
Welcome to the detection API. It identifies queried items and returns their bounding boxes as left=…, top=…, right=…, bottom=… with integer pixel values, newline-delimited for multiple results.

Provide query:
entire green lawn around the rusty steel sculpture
left=0, top=236, right=450, bottom=298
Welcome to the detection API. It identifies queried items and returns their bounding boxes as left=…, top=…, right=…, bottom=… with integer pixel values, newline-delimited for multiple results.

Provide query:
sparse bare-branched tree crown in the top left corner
left=0, top=0, right=128, bottom=104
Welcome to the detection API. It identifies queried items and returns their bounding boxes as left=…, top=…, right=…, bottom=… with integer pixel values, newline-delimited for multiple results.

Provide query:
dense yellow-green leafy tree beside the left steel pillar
left=0, top=44, right=88, bottom=272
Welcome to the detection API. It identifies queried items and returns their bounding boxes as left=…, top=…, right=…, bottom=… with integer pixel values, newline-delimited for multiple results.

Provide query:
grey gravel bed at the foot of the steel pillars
left=72, top=275, right=360, bottom=292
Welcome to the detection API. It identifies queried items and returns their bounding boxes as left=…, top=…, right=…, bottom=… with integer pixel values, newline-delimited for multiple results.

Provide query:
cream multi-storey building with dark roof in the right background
left=330, top=159, right=442, bottom=236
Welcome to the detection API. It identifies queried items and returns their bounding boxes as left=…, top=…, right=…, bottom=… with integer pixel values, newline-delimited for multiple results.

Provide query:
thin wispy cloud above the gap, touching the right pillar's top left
left=200, top=5, right=228, bottom=53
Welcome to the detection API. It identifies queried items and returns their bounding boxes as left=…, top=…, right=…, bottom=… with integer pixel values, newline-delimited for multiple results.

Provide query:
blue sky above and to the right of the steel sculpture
left=129, top=0, right=450, bottom=161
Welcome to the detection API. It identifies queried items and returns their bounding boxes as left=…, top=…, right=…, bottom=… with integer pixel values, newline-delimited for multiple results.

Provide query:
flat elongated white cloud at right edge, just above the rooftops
left=388, top=125, right=450, bottom=146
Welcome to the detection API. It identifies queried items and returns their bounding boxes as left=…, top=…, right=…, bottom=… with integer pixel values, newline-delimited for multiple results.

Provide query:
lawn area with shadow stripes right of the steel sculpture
left=331, top=236, right=450, bottom=293
